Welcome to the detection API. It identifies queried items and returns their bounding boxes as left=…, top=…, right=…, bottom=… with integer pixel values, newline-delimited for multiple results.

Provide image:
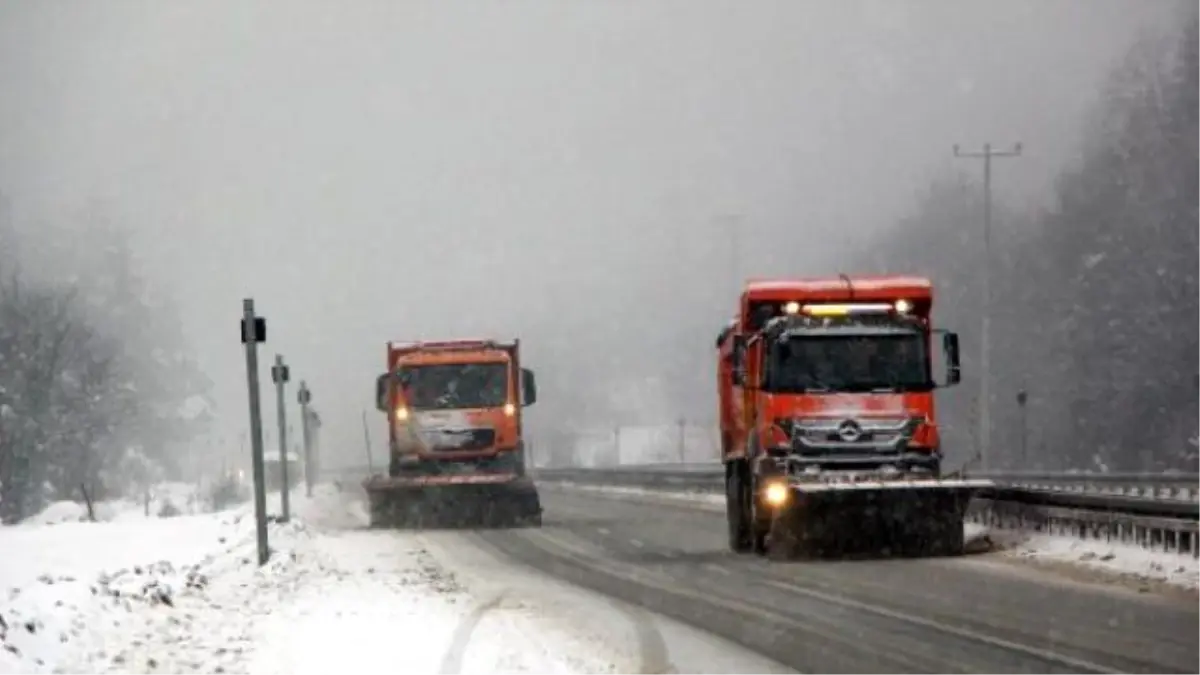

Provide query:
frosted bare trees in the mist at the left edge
left=0, top=201, right=211, bottom=520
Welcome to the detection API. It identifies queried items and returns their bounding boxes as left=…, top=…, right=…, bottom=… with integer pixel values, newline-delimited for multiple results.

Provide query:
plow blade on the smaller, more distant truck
left=362, top=474, right=541, bottom=528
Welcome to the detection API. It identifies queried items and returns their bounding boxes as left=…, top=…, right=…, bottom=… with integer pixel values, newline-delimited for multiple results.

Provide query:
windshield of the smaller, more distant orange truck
left=400, top=363, right=509, bottom=410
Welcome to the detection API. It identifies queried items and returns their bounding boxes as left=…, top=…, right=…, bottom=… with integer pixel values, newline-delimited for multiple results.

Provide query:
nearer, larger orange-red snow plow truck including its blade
left=716, top=275, right=991, bottom=558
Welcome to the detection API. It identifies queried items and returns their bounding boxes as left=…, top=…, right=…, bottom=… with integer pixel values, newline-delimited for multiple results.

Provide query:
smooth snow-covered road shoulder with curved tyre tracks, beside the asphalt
left=248, top=506, right=791, bottom=675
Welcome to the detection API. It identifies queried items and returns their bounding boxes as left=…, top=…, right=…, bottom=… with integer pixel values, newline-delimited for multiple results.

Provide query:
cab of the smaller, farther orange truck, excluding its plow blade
left=376, top=340, right=538, bottom=478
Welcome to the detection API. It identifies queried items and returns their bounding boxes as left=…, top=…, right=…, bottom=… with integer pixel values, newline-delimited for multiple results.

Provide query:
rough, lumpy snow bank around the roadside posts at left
left=0, top=482, right=336, bottom=673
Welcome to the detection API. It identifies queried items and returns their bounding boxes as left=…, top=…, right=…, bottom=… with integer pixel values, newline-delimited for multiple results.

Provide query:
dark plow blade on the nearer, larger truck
left=768, top=479, right=992, bottom=560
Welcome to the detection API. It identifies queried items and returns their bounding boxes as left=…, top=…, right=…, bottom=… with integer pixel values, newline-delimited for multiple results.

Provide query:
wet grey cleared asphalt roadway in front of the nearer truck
left=474, top=486, right=1200, bottom=675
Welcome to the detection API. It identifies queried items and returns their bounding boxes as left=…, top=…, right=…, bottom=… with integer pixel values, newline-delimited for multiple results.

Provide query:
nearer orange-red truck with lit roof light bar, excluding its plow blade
left=718, top=275, right=960, bottom=550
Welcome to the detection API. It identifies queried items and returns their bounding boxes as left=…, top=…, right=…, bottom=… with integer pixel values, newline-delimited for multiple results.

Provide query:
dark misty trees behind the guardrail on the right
left=844, top=6, right=1200, bottom=470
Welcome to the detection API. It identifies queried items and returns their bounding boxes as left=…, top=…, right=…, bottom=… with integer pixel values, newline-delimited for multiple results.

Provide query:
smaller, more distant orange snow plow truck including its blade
left=364, top=340, right=541, bottom=527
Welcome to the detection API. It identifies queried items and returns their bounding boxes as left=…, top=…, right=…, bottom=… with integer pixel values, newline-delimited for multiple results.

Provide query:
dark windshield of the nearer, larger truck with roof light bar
left=764, top=333, right=934, bottom=393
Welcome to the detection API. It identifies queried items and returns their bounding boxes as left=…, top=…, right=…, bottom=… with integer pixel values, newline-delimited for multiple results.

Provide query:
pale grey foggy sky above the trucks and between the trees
left=0, top=0, right=1176, bottom=462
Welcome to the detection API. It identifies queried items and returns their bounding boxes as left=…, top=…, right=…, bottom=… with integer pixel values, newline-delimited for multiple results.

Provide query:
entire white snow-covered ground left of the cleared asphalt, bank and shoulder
left=0, top=486, right=791, bottom=675
